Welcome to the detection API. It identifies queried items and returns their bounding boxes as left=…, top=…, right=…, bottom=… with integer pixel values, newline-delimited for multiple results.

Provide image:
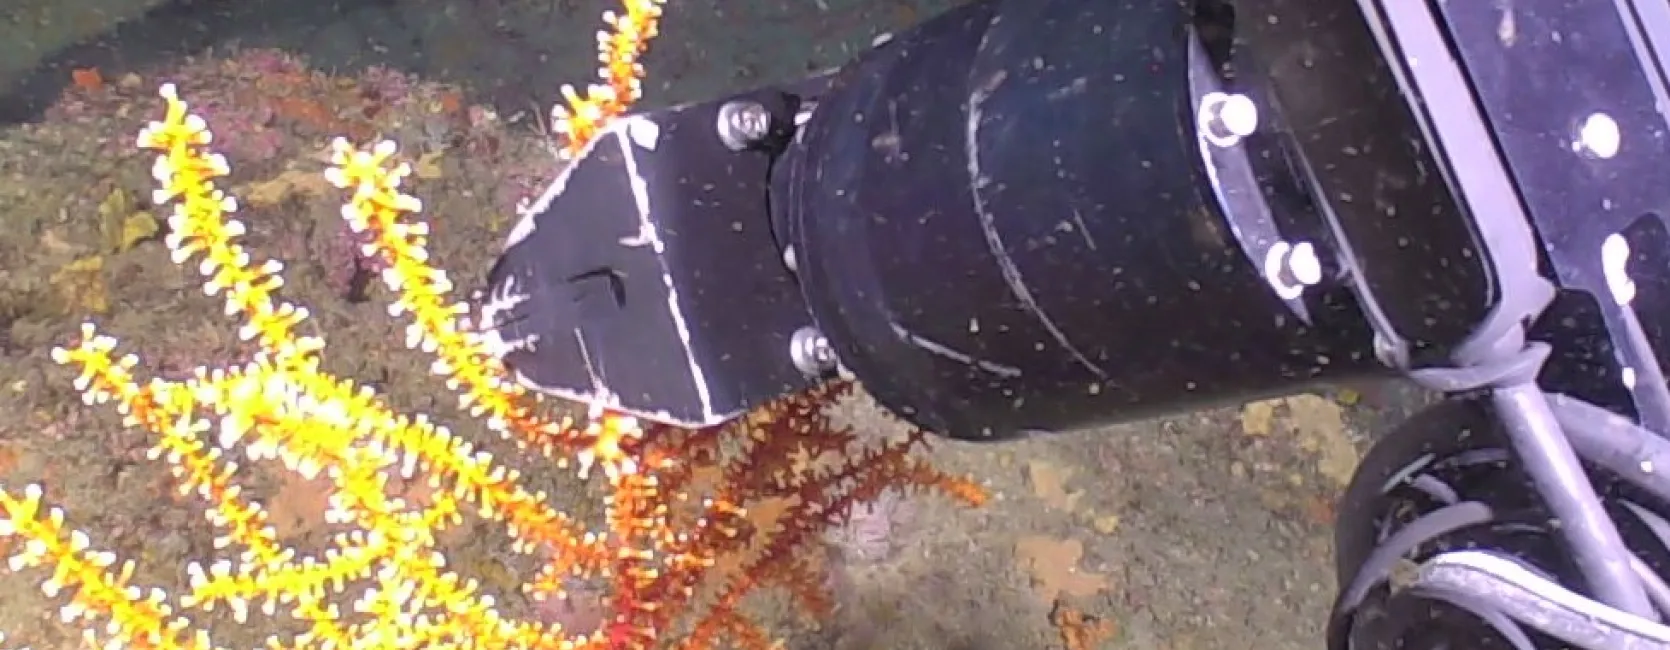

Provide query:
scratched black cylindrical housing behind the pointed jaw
left=773, top=0, right=1379, bottom=439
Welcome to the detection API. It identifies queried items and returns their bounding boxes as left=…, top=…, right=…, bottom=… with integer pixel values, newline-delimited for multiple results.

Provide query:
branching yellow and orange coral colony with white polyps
left=0, top=0, right=985, bottom=650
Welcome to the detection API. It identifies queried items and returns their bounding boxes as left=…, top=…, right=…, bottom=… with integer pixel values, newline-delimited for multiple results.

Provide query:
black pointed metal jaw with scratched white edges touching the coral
left=479, top=89, right=815, bottom=428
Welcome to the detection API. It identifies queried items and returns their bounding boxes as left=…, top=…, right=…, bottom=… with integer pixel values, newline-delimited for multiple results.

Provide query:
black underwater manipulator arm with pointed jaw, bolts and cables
left=484, top=0, right=1670, bottom=650
